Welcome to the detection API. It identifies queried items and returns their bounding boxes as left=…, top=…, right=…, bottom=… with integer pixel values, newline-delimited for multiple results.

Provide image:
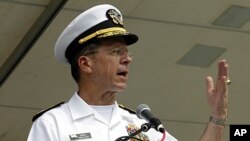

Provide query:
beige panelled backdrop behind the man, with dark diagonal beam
left=0, top=0, right=250, bottom=141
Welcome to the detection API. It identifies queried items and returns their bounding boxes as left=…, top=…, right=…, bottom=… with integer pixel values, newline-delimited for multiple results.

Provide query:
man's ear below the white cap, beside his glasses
left=78, top=56, right=92, bottom=73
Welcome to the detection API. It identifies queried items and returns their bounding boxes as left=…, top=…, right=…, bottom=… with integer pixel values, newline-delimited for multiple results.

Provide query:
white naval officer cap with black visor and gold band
left=54, top=4, right=138, bottom=63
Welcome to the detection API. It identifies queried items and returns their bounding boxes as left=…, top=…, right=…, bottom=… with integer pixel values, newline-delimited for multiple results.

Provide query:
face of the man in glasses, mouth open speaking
left=92, top=40, right=132, bottom=92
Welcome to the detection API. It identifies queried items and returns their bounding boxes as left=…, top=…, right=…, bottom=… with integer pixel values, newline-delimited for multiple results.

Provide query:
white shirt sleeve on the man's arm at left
left=27, top=118, right=59, bottom=141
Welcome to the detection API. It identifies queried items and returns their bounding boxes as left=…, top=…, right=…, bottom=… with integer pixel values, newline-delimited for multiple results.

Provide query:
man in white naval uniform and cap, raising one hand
left=28, top=4, right=228, bottom=141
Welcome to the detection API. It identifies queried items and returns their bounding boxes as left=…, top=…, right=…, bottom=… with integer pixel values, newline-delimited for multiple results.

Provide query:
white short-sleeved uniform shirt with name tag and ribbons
left=28, top=93, right=177, bottom=141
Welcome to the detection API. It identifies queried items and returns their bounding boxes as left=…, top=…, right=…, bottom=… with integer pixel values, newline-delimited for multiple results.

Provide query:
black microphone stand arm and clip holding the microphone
left=115, top=123, right=151, bottom=141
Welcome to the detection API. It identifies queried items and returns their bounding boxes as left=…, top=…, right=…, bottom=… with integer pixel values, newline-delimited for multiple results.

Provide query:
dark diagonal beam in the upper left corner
left=0, top=0, right=68, bottom=87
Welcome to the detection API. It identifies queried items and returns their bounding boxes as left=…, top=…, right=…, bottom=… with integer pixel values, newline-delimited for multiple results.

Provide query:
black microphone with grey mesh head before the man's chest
left=136, top=104, right=165, bottom=133
